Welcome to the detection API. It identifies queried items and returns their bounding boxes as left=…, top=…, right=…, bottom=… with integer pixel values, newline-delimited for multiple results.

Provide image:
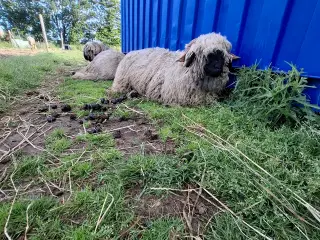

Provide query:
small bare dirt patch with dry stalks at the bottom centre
left=124, top=186, right=220, bottom=236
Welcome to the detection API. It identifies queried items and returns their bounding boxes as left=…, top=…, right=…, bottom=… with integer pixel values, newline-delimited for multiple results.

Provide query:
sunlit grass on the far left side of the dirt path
left=0, top=51, right=83, bottom=111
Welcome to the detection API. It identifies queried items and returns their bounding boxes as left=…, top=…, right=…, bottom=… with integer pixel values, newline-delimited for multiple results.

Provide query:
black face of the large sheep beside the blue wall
left=204, top=50, right=224, bottom=77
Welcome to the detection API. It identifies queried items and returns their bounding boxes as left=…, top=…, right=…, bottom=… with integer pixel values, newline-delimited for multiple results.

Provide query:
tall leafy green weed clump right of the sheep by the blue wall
left=230, top=65, right=318, bottom=127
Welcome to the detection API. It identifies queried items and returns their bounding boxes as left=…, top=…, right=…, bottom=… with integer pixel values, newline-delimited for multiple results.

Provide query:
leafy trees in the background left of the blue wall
left=0, top=0, right=120, bottom=46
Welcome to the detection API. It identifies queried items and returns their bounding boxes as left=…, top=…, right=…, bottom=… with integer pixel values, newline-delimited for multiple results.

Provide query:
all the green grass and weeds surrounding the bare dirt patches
left=0, top=49, right=320, bottom=240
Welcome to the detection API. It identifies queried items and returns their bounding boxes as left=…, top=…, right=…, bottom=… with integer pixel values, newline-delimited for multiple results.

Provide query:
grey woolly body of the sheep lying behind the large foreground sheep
left=72, top=49, right=124, bottom=80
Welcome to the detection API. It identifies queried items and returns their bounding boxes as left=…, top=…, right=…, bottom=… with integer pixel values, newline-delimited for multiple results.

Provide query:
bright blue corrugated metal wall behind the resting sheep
left=121, top=0, right=320, bottom=105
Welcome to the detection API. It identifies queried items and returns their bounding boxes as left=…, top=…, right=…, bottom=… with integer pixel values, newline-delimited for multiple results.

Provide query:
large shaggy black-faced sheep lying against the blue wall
left=110, top=33, right=237, bottom=105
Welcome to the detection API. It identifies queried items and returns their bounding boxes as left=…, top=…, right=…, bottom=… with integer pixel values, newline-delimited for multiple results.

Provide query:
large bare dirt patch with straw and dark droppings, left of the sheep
left=0, top=68, right=174, bottom=172
